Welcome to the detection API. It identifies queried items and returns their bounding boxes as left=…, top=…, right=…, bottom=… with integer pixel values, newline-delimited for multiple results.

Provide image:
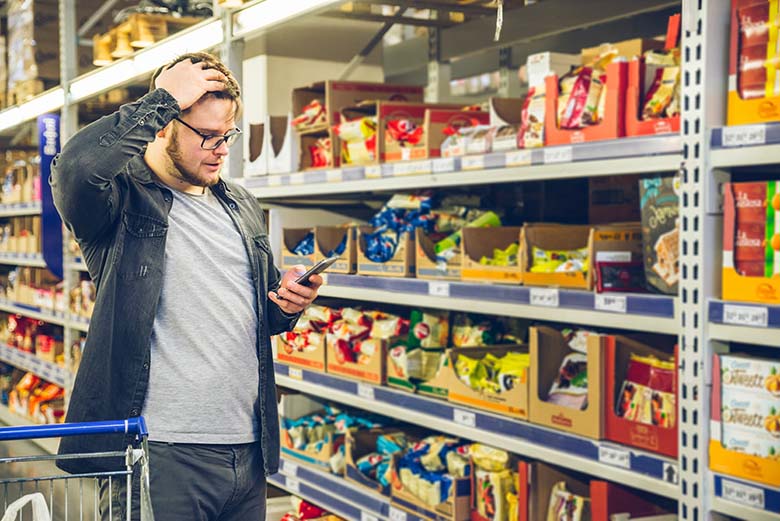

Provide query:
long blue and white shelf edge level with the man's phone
left=319, top=273, right=678, bottom=334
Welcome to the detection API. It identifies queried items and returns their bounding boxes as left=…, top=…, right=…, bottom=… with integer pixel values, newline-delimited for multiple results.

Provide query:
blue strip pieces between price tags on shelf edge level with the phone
left=328, top=273, right=674, bottom=318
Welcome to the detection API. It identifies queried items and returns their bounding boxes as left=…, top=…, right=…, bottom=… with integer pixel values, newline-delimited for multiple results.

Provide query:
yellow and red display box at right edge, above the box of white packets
left=722, top=183, right=780, bottom=304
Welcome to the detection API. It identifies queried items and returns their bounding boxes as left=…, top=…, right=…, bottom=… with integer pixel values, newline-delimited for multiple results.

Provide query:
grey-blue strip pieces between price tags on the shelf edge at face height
left=245, top=134, right=682, bottom=189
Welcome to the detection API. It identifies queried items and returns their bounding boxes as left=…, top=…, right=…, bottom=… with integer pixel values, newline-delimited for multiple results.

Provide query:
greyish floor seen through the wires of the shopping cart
left=0, top=441, right=96, bottom=521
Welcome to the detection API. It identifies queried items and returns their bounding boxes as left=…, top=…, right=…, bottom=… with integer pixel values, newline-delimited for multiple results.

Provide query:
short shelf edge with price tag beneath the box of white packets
left=711, top=474, right=780, bottom=521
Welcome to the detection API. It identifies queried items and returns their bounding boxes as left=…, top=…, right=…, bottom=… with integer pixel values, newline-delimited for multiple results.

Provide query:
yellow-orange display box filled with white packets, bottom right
left=709, top=354, right=780, bottom=486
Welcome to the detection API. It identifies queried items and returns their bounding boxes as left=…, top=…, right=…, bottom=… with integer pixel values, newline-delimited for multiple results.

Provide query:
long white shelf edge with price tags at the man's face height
left=243, top=136, right=682, bottom=199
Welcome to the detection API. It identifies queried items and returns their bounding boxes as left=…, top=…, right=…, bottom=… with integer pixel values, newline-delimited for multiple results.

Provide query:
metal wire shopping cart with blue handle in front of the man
left=0, top=417, right=154, bottom=521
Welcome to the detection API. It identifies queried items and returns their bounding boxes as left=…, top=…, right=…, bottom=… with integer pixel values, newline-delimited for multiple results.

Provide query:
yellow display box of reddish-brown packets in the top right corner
left=727, top=0, right=780, bottom=125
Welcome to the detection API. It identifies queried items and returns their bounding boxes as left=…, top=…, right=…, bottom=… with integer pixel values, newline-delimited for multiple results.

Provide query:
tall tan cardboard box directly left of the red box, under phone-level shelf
left=529, top=327, right=604, bottom=440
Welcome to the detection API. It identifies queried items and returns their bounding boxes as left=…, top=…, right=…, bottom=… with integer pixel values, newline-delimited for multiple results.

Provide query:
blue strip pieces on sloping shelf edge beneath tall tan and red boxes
left=274, top=363, right=676, bottom=482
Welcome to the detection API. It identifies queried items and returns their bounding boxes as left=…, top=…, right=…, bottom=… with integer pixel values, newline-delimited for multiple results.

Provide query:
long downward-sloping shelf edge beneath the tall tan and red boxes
left=275, top=363, right=679, bottom=498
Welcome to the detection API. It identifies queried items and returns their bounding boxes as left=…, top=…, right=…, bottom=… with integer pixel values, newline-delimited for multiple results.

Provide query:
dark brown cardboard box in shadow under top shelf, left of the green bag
left=588, top=175, right=641, bottom=224
